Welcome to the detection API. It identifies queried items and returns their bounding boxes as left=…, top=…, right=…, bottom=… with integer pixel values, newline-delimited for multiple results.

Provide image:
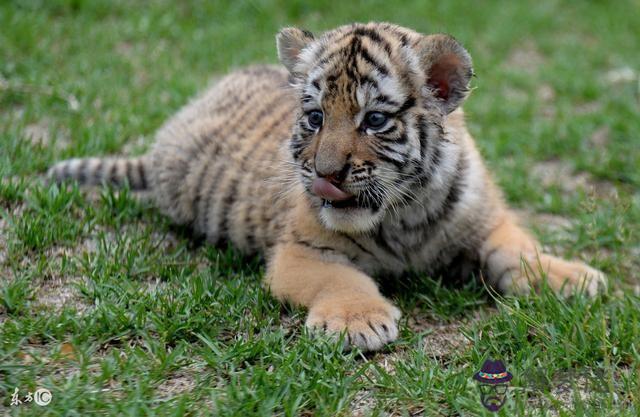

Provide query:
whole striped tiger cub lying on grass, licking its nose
left=49, top=23, right=606, bottom=350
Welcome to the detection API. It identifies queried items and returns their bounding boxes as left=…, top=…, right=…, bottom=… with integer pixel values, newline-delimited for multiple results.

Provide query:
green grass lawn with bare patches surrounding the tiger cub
left=0, top=0, right=640, bottom=416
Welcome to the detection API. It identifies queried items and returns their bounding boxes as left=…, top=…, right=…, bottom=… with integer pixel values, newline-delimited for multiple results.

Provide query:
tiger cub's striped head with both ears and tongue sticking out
left=277, top=23, right=472, bottom=233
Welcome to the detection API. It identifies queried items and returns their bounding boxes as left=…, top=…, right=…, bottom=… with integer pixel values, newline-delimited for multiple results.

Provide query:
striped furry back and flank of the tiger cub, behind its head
left=149, top=66, right=297, bottom=253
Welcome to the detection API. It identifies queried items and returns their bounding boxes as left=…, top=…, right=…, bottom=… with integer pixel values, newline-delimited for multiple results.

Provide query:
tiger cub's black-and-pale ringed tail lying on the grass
left=47, top=156, right=150, bottom=190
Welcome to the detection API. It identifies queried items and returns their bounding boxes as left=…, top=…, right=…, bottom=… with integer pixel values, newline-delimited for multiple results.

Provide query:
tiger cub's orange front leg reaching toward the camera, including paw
left=266, top=243, right=400, bottom=350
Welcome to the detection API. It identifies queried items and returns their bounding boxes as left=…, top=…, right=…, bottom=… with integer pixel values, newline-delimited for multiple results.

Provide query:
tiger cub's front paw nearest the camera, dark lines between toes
left=306, top=295, right=400, bottom=350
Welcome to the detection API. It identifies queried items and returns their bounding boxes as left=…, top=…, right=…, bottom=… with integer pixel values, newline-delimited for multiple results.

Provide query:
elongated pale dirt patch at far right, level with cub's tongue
left=532, top=160, right=618, bottom=198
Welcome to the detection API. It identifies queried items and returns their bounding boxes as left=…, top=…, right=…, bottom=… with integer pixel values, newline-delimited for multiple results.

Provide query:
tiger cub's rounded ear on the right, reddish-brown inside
left=419, top=34, right=473, bottom=114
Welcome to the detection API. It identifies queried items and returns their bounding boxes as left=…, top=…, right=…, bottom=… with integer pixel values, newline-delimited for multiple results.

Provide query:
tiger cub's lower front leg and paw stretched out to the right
left=480, top=212, right=606, bottom=296
